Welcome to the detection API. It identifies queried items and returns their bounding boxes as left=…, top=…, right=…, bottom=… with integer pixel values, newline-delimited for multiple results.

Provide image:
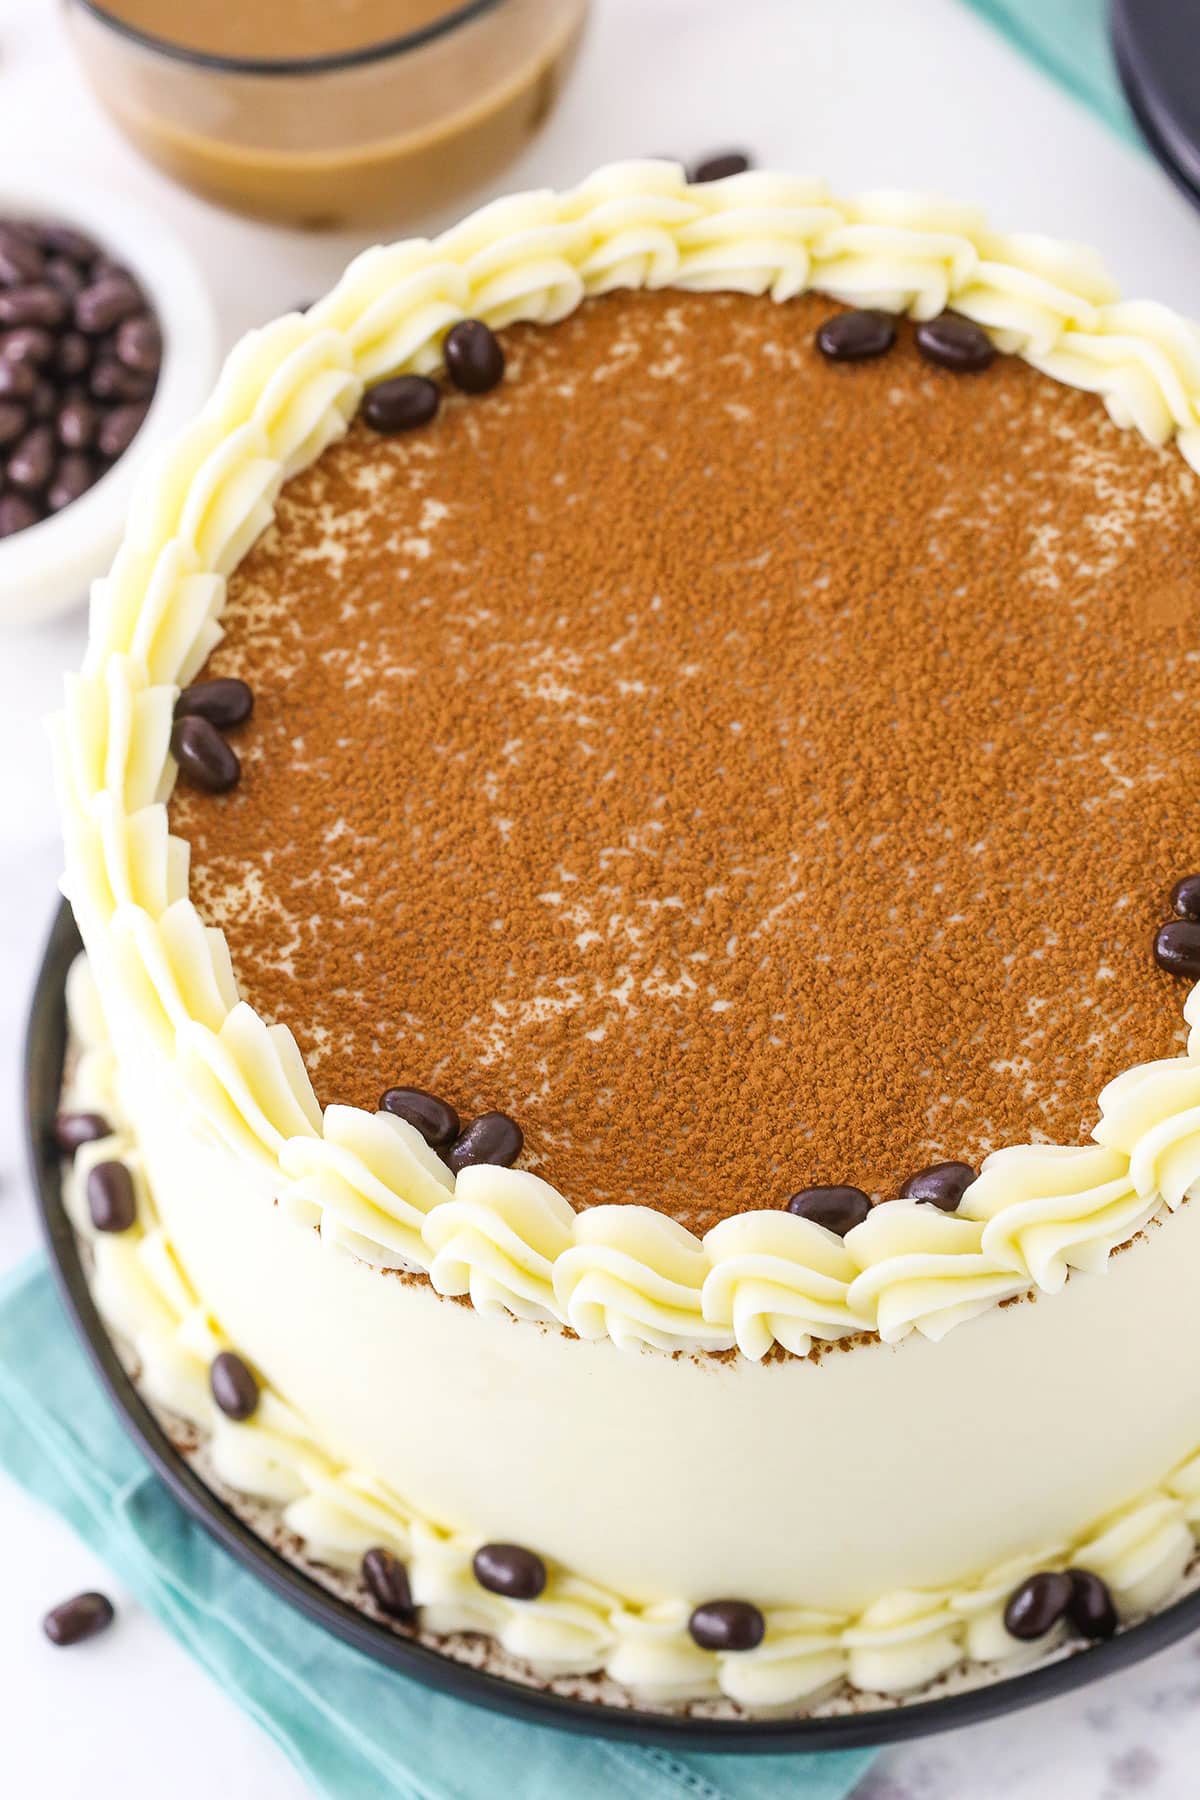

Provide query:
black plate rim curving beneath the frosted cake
left=25, top=905, right=1200, bottom=1753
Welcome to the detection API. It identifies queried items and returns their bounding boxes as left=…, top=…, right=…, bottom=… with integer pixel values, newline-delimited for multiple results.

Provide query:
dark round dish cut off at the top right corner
left=1112, top=0, right=1200, bottom=205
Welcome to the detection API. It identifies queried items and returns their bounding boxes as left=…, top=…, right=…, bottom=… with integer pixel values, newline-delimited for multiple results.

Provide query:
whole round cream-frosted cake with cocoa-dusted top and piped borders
left=58, top=164, right=1200, bottom=1710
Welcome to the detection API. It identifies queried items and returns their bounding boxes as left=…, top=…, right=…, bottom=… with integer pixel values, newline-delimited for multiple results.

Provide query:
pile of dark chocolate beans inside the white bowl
left=0, top=220, right=162, bottom=538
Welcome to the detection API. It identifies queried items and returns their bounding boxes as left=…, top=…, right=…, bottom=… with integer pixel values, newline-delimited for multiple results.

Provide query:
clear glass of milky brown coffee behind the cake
left=67, top=0, right=587, bottom=227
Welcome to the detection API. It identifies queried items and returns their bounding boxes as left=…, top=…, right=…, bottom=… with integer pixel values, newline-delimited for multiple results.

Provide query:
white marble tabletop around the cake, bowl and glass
left=0, top=0, right=1200, bottom=1800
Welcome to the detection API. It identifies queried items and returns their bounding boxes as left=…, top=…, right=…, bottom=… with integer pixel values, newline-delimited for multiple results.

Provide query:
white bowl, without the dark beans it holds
left=0, top=169, right=218, bottom=628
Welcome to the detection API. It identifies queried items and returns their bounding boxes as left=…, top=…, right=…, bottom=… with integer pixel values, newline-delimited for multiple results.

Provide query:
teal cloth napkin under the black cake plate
left=0, top=1255, right=871, bottom=1800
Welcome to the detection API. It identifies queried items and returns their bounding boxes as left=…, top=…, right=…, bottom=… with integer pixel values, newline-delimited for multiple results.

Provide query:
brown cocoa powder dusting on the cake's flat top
left=171, top=293, right=1200, bottom=1231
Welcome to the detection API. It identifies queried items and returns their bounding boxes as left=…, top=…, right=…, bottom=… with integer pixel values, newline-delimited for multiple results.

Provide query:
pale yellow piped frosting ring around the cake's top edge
left=54, top=162, right=1200, bottom=1359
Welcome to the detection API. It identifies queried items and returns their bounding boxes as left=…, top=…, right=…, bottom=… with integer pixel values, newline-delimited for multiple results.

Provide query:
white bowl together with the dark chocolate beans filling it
left=0, top=175, right=216, bottom=625
